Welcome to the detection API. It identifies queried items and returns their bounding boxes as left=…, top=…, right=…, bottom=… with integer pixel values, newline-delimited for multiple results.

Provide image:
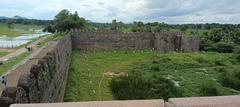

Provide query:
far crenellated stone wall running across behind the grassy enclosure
left=71, top=29, right=200, bottom=51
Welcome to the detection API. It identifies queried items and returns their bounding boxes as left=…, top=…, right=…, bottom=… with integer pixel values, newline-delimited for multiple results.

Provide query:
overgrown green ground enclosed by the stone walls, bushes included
left=64, top=50, right=240, bottom=101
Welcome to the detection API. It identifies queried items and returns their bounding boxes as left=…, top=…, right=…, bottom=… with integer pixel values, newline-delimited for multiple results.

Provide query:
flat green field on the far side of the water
left=0, top=23, right=43, bottom=37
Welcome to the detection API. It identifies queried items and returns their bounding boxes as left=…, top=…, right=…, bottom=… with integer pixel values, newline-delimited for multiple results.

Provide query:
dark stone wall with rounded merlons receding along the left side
left=0, top=36, right=72, bottom=107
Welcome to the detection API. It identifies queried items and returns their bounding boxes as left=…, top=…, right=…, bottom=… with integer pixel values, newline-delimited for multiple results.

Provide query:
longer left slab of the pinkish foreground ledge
left=10, top=100, right=164, bottom=107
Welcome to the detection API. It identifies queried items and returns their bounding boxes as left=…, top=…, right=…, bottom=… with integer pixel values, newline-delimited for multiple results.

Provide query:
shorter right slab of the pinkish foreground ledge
left=169, top=95, right=240, bottom=107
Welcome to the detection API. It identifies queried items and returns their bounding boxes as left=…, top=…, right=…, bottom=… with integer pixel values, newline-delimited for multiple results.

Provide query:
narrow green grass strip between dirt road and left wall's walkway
left=0, top=52, right=31, bottom=75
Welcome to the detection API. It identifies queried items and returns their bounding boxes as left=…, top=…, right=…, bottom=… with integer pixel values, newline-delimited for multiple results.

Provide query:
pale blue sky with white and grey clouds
left=0, top=0, right=240, bottom=24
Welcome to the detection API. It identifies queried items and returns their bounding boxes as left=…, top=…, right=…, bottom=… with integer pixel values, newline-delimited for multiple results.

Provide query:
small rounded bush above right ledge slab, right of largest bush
left=199, top=81, right=221, bottom=96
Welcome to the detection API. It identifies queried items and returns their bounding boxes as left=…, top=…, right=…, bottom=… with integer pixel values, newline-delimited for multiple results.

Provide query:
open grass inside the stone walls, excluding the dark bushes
left=64, top=50, right=240, bottom=101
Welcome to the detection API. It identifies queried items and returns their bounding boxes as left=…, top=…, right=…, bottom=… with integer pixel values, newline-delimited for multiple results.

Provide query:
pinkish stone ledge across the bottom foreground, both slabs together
left=10, top=96, right=240, bottom=107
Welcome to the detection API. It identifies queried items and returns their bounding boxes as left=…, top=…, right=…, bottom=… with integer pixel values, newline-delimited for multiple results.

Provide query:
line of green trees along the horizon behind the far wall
left=0, top=9, right=240, bottom=53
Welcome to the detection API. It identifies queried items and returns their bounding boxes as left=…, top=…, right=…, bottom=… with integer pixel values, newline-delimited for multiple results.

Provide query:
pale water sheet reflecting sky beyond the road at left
left=0, top=32, right=51, bottom=48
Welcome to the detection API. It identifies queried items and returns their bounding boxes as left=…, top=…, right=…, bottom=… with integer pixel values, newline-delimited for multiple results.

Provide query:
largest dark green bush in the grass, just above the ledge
left=110, top=72, right=181, bottom=100
